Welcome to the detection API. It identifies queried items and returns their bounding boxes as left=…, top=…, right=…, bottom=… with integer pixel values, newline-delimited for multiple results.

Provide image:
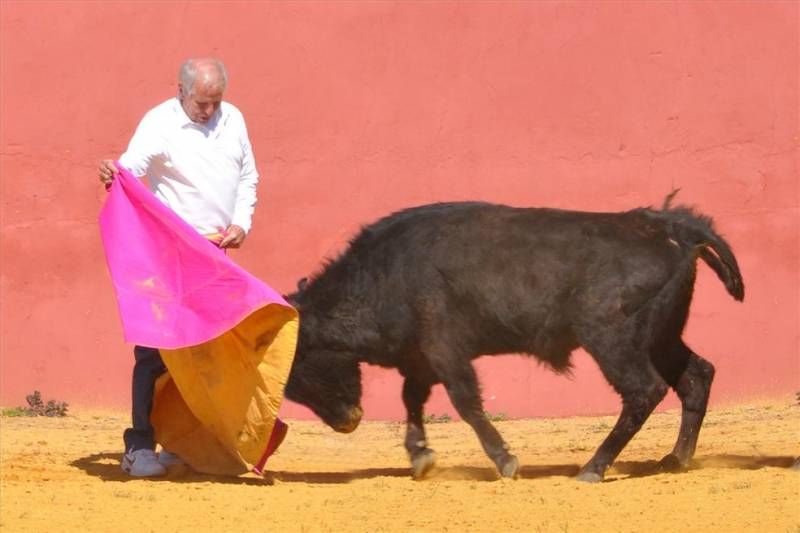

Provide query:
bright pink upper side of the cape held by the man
left=100, top=163, right=289, bottom=349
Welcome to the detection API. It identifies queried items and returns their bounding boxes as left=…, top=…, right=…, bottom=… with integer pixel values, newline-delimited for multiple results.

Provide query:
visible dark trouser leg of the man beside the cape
left=123, top=346, right=167, bottom=451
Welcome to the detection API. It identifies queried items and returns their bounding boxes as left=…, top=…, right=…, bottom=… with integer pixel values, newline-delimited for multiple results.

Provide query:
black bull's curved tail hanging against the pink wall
left=649, top=197, right=744, bottom=301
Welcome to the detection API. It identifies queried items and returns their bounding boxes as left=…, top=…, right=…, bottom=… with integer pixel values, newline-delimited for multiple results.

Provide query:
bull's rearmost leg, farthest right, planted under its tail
left=661, top=346, right=714, bottom=470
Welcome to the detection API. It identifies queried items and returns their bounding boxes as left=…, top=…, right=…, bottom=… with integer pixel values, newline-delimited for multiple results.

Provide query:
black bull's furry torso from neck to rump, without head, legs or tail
left=304, top=202, right=692, bottom=366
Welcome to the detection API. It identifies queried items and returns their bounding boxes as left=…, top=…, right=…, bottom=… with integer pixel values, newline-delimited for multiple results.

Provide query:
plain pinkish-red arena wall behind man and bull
left=0, top=1, right=800, bottom=418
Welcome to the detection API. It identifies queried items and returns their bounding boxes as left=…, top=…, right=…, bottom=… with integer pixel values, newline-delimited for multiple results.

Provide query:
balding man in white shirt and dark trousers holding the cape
left=99, top=58, right=258, bottom=477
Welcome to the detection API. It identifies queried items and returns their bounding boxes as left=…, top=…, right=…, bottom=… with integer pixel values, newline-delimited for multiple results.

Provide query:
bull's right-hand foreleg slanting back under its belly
left=436, top=359, right=519, bottom=478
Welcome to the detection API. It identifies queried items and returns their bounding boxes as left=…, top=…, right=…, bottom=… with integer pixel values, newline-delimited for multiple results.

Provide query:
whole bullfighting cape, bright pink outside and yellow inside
left=100, top=164, right=299, bottom=475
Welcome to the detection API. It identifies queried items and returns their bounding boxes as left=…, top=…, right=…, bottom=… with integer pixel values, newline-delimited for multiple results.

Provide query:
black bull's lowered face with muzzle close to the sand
left=286, top=343, right=363, bottom=433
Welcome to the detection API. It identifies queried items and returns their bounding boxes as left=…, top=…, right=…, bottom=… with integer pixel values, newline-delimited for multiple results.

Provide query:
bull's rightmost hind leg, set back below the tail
left=656, top=342, right=714, bottom=470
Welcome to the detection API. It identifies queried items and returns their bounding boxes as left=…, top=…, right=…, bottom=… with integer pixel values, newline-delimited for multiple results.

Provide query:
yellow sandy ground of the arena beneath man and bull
left=0, top=398, right=800, bottom=533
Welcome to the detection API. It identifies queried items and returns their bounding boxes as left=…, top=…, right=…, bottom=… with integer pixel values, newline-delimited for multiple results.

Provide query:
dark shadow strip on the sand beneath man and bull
left=70, top=453, right=795, bottom=486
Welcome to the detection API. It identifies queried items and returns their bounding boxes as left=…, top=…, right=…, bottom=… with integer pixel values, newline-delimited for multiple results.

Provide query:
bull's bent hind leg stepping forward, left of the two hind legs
left=578, top=349, right=667, bottom=482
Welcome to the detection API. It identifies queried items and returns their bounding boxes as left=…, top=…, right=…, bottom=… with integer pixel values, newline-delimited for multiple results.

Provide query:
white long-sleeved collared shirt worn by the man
left=119, top=98, right=258, bottom=235
